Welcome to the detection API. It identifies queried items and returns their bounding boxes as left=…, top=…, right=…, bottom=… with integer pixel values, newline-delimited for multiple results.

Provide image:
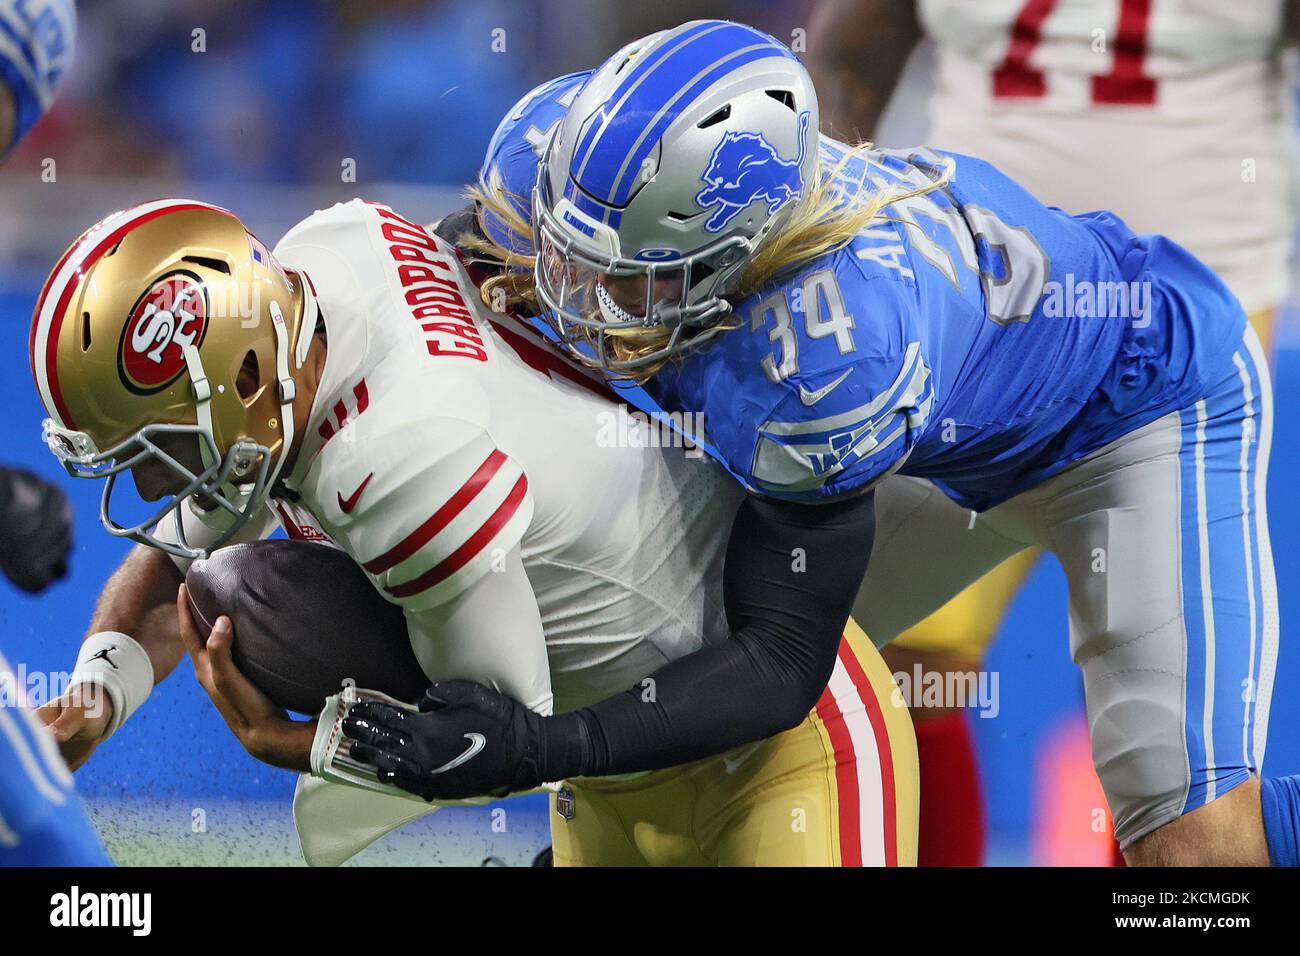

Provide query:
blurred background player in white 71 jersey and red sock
left=809, top=0, right=1300, bottom=866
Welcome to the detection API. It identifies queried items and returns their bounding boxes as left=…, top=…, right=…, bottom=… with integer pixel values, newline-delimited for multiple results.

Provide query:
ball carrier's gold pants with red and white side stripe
left=551, top=622, right=919, bottom=866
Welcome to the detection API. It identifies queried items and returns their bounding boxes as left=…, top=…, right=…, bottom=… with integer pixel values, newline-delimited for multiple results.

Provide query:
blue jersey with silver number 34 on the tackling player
left=489, top=85, right=1245, bottom=510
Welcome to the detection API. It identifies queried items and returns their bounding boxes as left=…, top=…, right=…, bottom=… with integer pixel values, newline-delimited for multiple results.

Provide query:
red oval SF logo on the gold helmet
left=117, top=271, right=208, bottom=395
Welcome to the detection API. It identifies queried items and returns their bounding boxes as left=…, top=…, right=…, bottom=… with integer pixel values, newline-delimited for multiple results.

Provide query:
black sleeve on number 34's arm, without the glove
left=541, top=493, right=875, bottom=780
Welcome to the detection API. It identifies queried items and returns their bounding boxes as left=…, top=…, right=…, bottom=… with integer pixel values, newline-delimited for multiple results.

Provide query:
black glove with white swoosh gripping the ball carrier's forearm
left=343, top=680, right=547, bottom=800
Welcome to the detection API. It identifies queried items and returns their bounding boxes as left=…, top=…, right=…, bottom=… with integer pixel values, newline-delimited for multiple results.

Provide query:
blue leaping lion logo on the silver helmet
left=696, top=111, right=809, bottom=233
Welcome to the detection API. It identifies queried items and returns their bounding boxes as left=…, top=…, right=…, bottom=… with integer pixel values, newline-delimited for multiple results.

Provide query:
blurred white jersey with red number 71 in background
left=919, top=0, right=1294, bottom=311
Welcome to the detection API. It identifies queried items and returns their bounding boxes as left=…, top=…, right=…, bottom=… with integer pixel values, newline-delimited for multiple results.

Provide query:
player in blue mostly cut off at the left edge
left=0, top=0, right=109, bottom=866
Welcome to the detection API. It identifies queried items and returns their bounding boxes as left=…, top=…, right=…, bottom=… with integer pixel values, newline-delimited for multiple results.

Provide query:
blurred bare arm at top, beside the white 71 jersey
left=806, top=0, right=922, bottom=143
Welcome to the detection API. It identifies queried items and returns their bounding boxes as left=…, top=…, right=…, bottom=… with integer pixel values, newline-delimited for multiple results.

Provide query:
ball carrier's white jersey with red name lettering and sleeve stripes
left=258, top=200, right=741, bottom=710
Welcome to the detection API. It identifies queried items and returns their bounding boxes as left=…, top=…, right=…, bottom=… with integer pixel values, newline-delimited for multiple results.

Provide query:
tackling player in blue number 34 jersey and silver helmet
left=350, top=21, right=1300, bottom=865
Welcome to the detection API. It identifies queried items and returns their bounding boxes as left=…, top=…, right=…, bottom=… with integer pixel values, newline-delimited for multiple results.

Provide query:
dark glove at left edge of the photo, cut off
left=0, top=468, right=73, bottom=593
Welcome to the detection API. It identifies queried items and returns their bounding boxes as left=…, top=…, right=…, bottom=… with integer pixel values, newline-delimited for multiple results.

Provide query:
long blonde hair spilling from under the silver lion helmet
left=464, top=143, right=954, bottom=384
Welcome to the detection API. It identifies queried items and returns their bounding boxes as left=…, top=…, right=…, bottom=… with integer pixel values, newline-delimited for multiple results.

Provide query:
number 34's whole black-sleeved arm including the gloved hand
left=342, top=493, right=875, bottom=800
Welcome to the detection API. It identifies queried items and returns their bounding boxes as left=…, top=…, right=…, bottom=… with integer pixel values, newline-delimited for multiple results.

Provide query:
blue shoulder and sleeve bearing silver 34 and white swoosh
left=683, top=256, right=935, bottom=501
